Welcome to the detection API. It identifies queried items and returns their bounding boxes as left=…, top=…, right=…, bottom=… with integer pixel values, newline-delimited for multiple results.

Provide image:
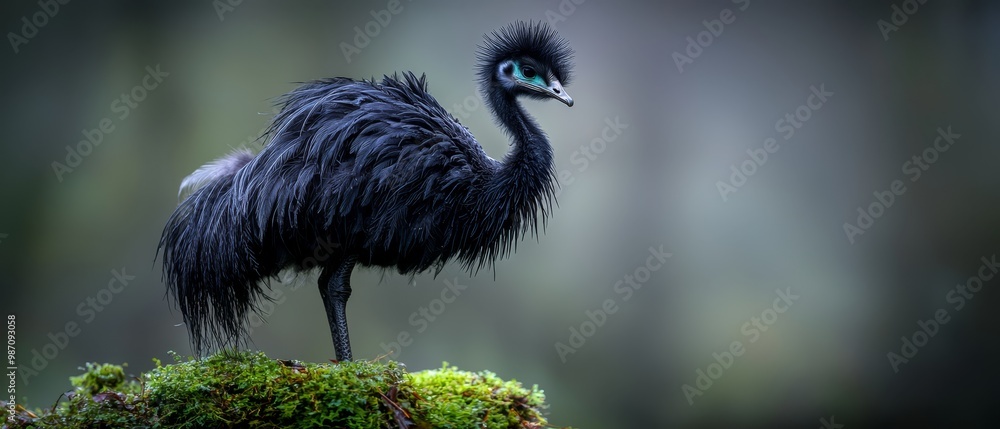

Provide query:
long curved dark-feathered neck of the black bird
left=466, top=91, right=555, bottom=266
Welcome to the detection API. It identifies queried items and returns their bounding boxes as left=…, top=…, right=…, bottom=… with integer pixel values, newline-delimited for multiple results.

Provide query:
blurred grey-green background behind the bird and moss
left=0, top=0, right=1000, bottom=428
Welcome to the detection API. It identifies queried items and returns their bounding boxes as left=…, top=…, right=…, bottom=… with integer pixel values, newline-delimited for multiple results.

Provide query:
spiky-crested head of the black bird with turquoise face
left=479, top=21, right=573, bottom=106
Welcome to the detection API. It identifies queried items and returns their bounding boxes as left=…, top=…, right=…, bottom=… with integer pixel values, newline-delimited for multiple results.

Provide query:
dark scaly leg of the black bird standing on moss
left=319, top=256, right=355, bottom=361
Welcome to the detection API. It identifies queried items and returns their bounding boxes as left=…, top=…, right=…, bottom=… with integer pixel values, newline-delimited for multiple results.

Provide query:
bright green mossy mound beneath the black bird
left=1, top=352, right=564, bottom=429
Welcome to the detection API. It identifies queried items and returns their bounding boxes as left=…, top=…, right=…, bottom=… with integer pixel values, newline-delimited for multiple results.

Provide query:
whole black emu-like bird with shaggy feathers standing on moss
left=157, top=22, right=573, bottom=360
